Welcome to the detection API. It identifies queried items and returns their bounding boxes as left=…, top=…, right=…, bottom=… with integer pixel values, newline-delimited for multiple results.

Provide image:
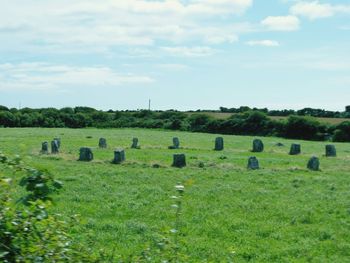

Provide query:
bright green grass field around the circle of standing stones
left=0, top=129, right=350, bottom=262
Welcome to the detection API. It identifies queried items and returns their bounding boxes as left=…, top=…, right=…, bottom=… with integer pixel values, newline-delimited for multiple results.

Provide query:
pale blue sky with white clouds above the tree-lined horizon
left=0, top=0, right=350, bottom=110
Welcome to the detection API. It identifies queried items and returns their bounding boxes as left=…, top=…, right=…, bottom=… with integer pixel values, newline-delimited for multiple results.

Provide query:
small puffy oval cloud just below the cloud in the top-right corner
left=261, top=15, right=300, bottom=31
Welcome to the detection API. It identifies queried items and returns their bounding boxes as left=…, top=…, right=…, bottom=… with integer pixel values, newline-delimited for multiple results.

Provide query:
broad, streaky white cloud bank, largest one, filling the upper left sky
left=0, top=0, right=252, bottom=53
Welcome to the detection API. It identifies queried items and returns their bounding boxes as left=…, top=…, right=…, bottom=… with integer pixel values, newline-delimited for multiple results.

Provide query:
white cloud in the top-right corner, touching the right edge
left=290, top=1, right=350, bottom=20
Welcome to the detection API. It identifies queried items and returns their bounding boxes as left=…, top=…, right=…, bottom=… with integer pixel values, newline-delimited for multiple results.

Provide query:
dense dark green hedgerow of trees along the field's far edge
left=0, top=106, right=350, bottom=142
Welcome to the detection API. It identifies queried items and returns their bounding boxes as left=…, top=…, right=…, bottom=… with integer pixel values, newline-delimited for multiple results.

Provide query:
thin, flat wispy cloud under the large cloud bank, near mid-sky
left=161, top=46, right=218, bottom=57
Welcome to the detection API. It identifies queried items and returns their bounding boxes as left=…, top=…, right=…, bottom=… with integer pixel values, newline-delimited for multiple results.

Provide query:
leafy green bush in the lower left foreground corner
left=0, top=153, right=97, bottom=263
